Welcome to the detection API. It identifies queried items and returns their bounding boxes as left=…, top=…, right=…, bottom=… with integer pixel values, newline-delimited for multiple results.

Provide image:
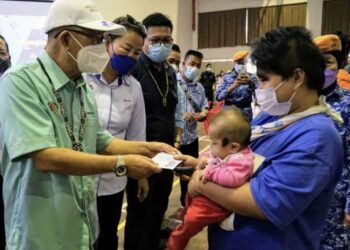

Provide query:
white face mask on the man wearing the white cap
left=67, top=33, right=110, bottom=73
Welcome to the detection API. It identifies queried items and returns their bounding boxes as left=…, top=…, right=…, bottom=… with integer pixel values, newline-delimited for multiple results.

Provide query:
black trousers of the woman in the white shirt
left=97, top=190, right=124, bottom=250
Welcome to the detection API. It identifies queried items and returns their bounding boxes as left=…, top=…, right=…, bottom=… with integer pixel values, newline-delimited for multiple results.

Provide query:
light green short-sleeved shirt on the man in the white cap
left=0, top=52, right=112, bottom=250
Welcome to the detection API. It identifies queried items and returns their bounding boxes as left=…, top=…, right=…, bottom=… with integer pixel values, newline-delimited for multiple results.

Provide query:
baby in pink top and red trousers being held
left=168, top=108, right=254, bottom=250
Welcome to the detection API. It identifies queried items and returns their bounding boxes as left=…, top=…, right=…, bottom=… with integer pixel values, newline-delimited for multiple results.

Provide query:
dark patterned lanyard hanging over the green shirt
left=37, top=58, right=86, bottom=152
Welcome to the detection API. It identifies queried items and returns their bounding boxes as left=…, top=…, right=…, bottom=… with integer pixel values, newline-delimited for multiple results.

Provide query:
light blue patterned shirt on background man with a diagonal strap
left=177, top=73, right=208, bottom=145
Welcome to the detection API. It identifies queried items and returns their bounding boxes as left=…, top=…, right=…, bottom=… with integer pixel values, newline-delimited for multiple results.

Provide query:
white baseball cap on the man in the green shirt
left=45, top=0, right=125, bottom=35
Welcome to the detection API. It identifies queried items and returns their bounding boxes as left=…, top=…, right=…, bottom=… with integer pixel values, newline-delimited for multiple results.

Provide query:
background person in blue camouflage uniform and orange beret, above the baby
left=215, top=50, right=258, bottom=121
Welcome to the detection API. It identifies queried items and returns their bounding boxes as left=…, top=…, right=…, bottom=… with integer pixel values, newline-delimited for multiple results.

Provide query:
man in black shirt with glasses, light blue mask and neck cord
left=124, top=13, right=181, bottom=250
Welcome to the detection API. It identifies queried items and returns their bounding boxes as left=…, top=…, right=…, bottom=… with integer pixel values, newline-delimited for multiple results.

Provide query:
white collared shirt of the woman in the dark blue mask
left=84, top=74, right=146, bottom=196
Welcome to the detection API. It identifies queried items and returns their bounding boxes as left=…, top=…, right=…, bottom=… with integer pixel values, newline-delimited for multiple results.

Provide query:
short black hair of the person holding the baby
left=251, top=26, right=326, bottom=93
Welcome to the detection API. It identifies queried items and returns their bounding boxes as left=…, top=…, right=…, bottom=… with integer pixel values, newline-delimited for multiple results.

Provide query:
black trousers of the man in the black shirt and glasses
left=124, top=170, right=174, bottom=250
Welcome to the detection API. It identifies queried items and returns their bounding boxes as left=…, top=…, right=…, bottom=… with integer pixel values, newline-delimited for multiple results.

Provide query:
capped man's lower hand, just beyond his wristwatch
left=123, top=155, right=162, bottom=179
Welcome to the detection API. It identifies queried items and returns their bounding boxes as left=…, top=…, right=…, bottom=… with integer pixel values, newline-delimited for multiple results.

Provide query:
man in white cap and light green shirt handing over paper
left=0, top=0, right=175, bottom=250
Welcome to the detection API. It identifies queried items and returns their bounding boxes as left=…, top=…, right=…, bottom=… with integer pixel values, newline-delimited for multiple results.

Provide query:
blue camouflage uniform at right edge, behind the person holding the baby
left=321, top=85, right=350, bottom=250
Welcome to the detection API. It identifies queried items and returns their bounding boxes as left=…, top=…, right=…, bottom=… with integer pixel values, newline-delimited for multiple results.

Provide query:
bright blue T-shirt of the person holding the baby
left=209, top=113, right=344, bottom=250
